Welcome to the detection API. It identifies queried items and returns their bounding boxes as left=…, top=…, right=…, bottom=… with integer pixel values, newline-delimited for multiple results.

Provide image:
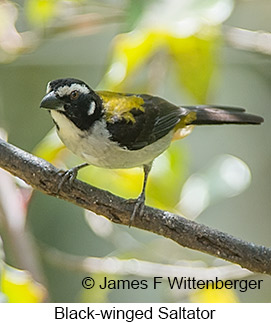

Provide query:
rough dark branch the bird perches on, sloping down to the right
left=0, top=139, right=271, bottom=274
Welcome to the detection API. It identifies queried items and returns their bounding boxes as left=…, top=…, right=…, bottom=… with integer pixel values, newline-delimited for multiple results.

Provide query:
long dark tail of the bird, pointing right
left=182, top=105, right=264, bottom=125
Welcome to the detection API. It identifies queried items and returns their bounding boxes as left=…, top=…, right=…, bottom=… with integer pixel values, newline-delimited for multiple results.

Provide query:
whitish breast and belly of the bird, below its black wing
left=51, top=111, right=173, bottom=169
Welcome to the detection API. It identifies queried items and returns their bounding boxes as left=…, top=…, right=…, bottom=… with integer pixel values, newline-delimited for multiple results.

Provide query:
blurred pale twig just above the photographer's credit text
left=39, top=243, right=252, bottom=280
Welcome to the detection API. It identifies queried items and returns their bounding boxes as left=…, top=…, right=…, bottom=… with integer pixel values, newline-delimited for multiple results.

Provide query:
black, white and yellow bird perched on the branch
left=40, top=78, right=264, bottom=225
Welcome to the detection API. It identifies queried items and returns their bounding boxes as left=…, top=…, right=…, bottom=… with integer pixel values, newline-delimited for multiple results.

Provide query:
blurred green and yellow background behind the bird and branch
left=0, top=0, right=271, bottom=302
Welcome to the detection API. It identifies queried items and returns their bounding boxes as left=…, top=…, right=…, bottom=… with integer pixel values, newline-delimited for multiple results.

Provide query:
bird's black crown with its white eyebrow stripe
left=46, top=79, right=91, bottom=97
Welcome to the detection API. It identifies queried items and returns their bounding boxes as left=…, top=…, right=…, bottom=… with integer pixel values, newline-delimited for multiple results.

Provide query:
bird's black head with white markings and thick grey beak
left=40, top=78, right=103, bottom=130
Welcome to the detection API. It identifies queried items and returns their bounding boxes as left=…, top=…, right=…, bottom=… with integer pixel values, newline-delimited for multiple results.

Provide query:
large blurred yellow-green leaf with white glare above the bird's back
left=99, top=0, right=233, bottom=98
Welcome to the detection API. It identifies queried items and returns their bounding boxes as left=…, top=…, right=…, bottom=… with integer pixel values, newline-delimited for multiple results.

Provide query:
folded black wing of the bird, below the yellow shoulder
left=107, top=94, right=184, bottom=150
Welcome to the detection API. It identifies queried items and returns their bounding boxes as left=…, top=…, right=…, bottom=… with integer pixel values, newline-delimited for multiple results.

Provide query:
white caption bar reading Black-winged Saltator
left=0, top=303, right=270, bottom=323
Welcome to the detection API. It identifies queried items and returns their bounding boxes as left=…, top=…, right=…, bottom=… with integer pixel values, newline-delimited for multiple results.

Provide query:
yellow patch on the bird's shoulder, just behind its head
left=97, top=91, right=145, bottom=123
